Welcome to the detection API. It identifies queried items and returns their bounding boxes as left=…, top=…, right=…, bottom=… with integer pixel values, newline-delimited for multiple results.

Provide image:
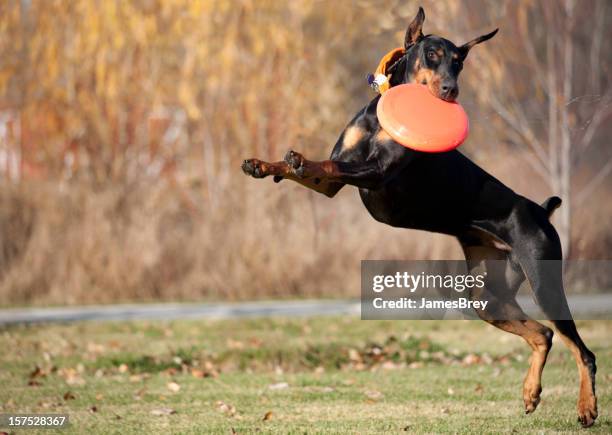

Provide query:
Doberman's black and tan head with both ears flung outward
left=391, top=8, right=499, bottom=101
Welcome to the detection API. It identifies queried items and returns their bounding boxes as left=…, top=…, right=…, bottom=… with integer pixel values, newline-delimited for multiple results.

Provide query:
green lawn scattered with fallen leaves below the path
left=0, top=318, right=612, bottom=434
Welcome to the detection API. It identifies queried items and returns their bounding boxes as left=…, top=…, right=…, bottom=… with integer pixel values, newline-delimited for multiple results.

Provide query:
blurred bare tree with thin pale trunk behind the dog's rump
left=460, top=0, right=612, bottom=255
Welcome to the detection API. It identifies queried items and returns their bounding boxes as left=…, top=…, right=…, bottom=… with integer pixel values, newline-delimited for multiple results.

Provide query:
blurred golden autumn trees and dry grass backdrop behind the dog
left=0, top=0, right=612, bottom=306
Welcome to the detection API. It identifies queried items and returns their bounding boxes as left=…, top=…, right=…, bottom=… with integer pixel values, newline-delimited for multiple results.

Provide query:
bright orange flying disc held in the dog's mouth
left=376, top=84, right=469, bottom=153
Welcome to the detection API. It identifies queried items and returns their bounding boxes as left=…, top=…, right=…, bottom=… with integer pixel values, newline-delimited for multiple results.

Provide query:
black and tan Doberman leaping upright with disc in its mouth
left=242, top=8, right=597, bottom=427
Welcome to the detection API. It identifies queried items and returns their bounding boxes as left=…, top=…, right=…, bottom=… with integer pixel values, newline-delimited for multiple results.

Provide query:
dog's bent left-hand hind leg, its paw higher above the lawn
left=462, top=242, right=553, bottom=414
